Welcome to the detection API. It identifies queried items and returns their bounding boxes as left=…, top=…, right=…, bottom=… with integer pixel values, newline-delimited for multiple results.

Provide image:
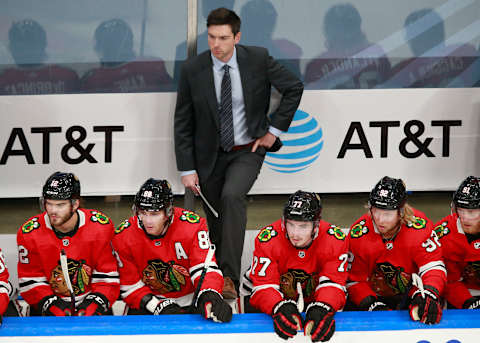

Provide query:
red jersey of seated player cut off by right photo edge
left=435, top=213, right=480, bottom=308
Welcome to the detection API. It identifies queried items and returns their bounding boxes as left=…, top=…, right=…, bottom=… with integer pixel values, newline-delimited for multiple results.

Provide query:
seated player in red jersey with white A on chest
left=113, top=178, right=232, bottom=322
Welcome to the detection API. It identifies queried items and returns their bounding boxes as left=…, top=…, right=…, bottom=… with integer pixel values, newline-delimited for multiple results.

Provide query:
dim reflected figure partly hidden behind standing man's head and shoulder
left=240, top=0, right=303, bottom=77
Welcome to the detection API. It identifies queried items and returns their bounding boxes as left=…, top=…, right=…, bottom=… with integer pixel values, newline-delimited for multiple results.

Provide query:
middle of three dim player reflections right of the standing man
left=305, top=3, right=390, bottom=89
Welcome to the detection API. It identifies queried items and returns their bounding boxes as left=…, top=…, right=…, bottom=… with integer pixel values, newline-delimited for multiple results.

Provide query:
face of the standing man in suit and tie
left=208, top=25, right=241, bottom=62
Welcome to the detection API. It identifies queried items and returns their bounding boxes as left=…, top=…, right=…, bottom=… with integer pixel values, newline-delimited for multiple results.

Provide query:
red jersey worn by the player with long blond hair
left=347, top=209, right=446, bottom=309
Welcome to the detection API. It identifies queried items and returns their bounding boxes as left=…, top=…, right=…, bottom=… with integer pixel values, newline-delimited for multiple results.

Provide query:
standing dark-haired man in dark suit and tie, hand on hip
left=174, top=8, right=303, bottom=298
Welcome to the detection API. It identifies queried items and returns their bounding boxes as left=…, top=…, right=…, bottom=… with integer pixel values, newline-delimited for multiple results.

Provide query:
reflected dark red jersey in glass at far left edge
left=0, top=64, right=80, bottom=95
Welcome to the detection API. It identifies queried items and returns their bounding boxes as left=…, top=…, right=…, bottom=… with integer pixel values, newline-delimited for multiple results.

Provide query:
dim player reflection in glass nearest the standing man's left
left=81, top=18, right=173, bottom=93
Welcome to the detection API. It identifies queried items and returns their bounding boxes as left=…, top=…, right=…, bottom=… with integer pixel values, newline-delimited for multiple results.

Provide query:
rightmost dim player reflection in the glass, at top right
left=388, top=8, right=478, bottom=88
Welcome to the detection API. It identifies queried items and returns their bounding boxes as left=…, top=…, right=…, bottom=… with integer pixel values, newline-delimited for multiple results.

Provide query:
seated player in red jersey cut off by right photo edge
left=435, top=176, right=480, bottom=309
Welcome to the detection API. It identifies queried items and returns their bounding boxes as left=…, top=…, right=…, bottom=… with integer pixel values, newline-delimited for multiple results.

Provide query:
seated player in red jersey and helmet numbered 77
left=239, top=190, right=348, bottom=342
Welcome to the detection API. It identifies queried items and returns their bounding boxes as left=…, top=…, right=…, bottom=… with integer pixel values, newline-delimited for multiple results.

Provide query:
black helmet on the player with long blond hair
left=368, top=176, right=407, bottom=210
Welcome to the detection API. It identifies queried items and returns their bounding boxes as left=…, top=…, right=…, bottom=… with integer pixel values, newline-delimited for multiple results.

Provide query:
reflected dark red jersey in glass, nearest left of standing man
left=82, top=61, right=173, bottom=93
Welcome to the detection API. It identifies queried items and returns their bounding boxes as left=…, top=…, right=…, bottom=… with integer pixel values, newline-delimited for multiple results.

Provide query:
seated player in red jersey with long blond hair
left=347, top=176, right=446, bottom=324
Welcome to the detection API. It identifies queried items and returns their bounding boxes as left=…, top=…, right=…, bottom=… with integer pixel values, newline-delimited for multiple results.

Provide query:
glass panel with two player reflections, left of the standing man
left=0, top=0, right=187, bottom=95
